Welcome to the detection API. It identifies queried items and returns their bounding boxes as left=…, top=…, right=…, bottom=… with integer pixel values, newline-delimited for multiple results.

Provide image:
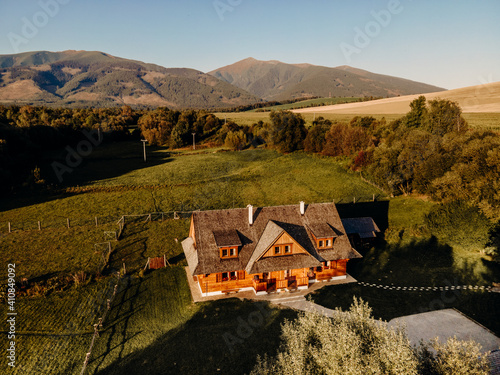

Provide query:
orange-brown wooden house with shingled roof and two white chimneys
left=182, top=202, right=361, bottom=296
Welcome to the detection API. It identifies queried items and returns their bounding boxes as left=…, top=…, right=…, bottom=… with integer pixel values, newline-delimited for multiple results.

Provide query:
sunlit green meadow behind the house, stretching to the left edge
left=0, top=143, right=384, bottom=284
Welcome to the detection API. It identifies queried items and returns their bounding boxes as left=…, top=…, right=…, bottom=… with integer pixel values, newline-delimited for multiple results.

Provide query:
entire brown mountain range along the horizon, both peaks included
left=0, top=51, right=443, bottom=109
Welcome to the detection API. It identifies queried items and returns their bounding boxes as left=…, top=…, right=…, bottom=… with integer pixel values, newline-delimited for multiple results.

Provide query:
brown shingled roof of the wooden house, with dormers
left=182, top=203, right=361, bottom=275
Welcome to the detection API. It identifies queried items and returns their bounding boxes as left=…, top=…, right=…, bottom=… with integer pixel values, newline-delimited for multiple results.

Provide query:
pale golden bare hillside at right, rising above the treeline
left=294, top=82, right=500, bottom=115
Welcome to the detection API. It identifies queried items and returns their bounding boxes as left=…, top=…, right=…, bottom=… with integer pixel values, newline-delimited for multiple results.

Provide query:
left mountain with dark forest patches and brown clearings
left=0, top=51, right=259, bottom=108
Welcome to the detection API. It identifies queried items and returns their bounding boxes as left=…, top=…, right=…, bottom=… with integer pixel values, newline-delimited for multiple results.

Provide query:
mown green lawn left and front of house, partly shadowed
left=0, top=267, right=295, bottom=375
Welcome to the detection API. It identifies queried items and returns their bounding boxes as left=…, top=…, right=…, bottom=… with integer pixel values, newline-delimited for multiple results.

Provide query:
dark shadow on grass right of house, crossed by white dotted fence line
left=312, top=237, right=500, bottom=334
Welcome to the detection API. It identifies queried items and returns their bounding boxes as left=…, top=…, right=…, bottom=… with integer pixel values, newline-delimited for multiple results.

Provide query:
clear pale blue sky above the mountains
left=0, top=0, right=500, bottom=89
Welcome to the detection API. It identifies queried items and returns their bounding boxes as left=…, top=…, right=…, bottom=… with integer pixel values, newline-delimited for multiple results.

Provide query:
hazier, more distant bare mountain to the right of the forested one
left=209, top=58, right=444, bottom=100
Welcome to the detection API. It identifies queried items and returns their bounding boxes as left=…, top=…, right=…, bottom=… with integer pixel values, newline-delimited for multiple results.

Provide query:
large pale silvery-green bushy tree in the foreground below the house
left=251, top=298, right=418, bottom=375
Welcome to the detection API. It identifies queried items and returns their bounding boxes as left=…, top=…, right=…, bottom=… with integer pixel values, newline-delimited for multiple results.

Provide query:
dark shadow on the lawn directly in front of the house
left=94, top=299, right=296, bottom=375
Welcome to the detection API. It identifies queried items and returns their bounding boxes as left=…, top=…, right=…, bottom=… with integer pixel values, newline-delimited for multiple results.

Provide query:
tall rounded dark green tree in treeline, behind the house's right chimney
left=269, top=111, right=307, bottom=152
